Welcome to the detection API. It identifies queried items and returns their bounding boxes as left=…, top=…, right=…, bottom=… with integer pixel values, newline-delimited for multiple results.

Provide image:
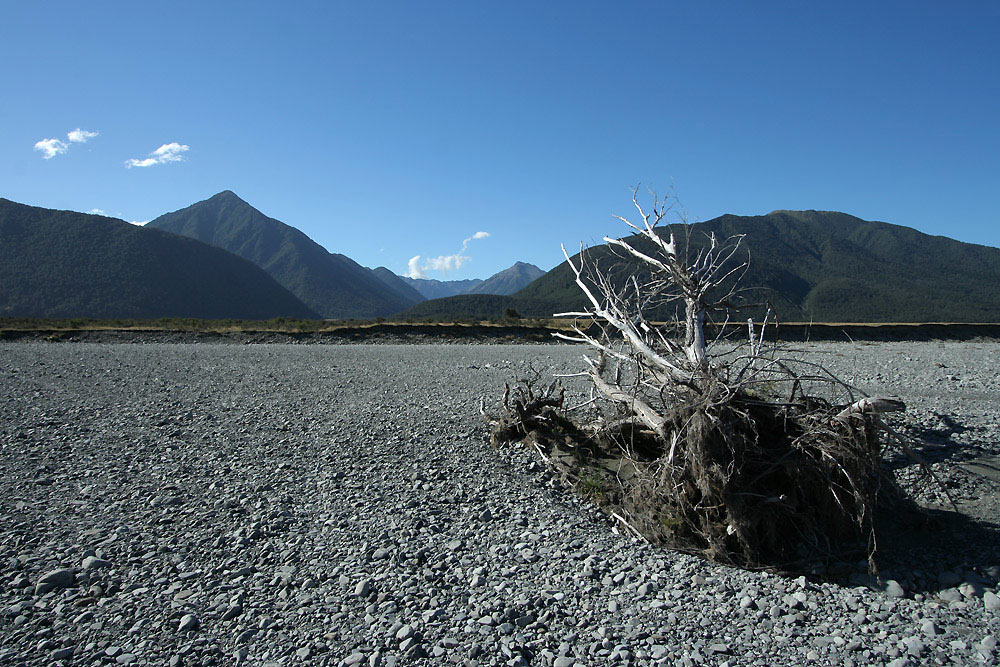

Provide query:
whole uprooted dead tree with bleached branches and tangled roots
left=484, top=190, right=920, bottom=566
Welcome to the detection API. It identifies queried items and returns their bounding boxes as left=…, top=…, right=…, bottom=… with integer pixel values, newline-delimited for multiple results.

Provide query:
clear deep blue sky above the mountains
left=0, top=0, right=1000, bottom=278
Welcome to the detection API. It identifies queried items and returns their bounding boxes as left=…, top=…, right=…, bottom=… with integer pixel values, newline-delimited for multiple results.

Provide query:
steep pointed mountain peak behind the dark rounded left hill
left=146, top=190, right=414, bottom=319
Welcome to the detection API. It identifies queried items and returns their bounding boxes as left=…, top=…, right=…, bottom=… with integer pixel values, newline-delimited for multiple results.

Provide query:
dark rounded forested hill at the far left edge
left=0, top=199, right=316, bottom=319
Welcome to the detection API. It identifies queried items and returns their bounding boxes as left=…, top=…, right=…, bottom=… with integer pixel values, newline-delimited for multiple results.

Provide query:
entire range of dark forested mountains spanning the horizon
left=7, top=190, right=1000, bottom=322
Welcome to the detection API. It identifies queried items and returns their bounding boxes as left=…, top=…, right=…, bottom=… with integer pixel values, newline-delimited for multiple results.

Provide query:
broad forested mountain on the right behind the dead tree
left=403, top=211, right=1000, bottom=322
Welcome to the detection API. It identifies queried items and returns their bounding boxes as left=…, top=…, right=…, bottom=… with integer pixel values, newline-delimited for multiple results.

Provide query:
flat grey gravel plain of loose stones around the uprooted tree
left=0, top=342, right=1000, bottom=667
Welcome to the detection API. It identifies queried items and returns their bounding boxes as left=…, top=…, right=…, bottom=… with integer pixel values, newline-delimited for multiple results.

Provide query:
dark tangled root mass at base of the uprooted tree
left=492, top=378, right=903, bottom=569
